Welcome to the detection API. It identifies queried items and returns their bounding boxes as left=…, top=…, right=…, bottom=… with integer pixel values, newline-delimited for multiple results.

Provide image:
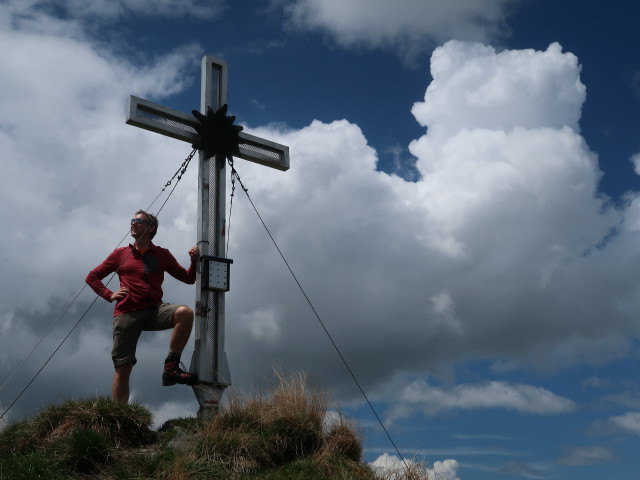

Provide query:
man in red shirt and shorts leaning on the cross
left=86, top=210, right=199, bottom=402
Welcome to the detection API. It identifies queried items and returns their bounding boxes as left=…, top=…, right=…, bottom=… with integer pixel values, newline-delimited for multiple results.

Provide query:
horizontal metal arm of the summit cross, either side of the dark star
left=127, top=95, right=289, bottom=170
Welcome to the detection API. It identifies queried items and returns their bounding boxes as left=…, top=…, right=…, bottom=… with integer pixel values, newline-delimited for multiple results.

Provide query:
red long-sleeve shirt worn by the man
left=86, top=244, right=196, bottom=316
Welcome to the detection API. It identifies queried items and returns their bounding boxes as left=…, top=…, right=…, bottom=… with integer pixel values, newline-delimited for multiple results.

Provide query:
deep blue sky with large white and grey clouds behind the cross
left=0, top=0, right=640, bottom=480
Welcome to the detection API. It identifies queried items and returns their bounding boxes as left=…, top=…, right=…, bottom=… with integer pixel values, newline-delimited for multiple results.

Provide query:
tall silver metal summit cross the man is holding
left=127, top=55, right=289, bottom=417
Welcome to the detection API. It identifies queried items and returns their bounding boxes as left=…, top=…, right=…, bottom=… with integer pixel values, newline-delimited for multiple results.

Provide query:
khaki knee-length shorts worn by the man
left=111, top=303, right=180, bottom=367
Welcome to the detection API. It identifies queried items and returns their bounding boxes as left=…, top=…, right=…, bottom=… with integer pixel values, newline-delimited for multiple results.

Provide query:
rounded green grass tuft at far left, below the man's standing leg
left=0, top=397, right=156, bottom=480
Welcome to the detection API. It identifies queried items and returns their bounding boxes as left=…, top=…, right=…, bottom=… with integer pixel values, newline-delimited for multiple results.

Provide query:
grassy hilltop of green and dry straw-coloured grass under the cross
left=0, top=375, right=427, bottom=480
